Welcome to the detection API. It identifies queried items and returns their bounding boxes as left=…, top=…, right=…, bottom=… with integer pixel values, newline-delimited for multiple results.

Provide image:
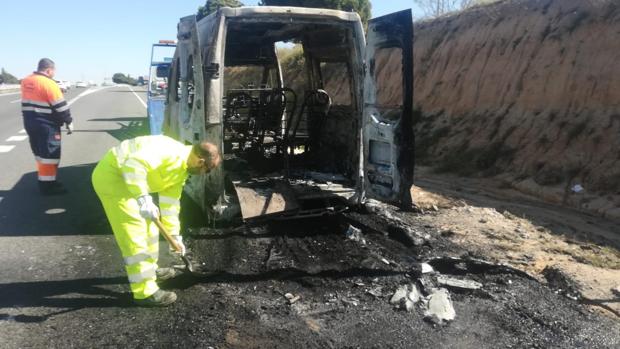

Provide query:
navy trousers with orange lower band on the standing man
left=24, top=117, right=60, bottom=182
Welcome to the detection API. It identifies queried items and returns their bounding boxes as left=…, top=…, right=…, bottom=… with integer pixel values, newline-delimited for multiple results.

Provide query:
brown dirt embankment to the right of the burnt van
left=412, top=0, right=620, bottom=218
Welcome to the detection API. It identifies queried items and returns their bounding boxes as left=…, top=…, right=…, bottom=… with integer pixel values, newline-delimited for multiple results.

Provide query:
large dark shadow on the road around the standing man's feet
left=0, top=164, right=112, bottom=236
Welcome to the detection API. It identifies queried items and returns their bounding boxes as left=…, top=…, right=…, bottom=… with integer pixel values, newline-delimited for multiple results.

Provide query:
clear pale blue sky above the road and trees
left=0, top=0, right=422, bottom=83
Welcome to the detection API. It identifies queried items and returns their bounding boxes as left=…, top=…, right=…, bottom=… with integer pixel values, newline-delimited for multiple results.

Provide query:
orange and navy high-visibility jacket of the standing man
left=21, top=72, right=73, bottom=126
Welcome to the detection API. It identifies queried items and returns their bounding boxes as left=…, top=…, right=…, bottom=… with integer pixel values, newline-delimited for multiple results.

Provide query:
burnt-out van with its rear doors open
left=163, top=6, right=413, bottom=221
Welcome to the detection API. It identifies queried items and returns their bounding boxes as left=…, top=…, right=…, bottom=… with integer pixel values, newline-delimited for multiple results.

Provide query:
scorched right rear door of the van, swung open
left=363, top=10, right=413, bottom=208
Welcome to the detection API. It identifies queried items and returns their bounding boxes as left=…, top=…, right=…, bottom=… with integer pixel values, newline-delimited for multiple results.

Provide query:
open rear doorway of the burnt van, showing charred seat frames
left=222, top=21, right=359, bottom=180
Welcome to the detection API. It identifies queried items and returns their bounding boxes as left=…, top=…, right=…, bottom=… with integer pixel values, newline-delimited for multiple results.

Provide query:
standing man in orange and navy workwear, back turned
left=21, top=58, right=73, bottom=195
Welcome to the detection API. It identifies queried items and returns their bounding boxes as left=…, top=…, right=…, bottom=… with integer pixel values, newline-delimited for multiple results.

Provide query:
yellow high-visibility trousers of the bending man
left=92, top=151, right=159, bottom=299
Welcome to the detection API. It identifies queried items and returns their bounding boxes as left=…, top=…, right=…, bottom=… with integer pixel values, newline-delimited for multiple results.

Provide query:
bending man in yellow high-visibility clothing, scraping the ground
left=92, top=136, right=221, bottom=306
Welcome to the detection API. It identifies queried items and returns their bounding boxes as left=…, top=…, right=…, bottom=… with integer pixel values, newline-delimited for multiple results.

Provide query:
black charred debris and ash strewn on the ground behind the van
left=163, top=200, right=619, bottom=347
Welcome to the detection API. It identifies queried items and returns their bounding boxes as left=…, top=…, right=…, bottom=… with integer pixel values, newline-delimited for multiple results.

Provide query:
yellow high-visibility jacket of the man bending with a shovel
left=111, top=136, right=192, bottom=235
